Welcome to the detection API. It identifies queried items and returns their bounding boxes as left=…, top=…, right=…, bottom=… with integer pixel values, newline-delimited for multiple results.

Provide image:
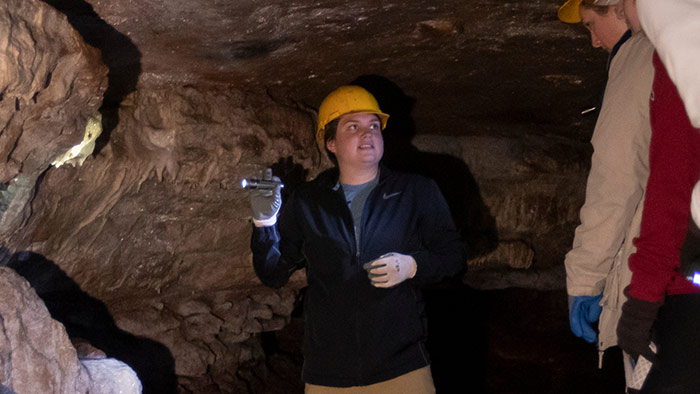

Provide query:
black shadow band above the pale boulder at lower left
left=0, top=248, right=177, bottom=394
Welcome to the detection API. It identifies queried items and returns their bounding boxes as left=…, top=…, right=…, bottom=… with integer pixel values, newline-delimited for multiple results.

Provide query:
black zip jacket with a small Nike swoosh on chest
left=251, top=167, right=466, bottom=387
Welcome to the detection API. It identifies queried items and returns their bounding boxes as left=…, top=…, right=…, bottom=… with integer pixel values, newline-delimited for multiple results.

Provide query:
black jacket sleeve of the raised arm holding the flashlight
left=250, top=195, right=304, bottom=288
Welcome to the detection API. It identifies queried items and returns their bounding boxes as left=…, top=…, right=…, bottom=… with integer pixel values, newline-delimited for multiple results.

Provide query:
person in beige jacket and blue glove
left=560, top=0, right=654, bottom=388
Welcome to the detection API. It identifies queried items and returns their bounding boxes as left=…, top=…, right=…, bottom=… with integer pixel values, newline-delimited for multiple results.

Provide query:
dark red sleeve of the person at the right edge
left=629, top=56, right=700, bottom=302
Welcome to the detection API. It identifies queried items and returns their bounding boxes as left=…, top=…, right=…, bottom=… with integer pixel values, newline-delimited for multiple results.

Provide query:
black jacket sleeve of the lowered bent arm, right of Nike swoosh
left=412, top=180, right=467, bottom=285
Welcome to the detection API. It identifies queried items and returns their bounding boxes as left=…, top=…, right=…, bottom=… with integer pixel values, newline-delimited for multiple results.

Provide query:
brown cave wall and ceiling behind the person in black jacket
left=0, top=0, right=605, bottom=393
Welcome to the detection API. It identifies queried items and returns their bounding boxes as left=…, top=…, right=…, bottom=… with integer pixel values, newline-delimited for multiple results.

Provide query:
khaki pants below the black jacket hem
left=304, top=366, right=435, bottom=394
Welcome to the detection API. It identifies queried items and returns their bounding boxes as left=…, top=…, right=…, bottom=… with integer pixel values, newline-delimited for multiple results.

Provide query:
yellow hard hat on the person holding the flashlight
left=316, top=85, right=389, bottom=145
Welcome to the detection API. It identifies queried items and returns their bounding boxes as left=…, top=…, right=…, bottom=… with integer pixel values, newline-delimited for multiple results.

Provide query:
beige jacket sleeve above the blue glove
left=565, top=37, right=653, bottom=296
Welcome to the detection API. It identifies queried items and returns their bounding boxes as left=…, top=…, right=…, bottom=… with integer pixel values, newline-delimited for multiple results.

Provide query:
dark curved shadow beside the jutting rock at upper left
left=42, top=0, right=141, bottom=154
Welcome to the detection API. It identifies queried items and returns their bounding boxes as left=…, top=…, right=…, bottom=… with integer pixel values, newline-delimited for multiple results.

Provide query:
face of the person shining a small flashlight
left=326, top=112, right=384, bottom=171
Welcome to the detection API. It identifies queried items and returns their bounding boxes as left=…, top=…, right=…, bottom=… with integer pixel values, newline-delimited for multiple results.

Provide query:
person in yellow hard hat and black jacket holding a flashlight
left=246, top=86, right=466, bottom=394
